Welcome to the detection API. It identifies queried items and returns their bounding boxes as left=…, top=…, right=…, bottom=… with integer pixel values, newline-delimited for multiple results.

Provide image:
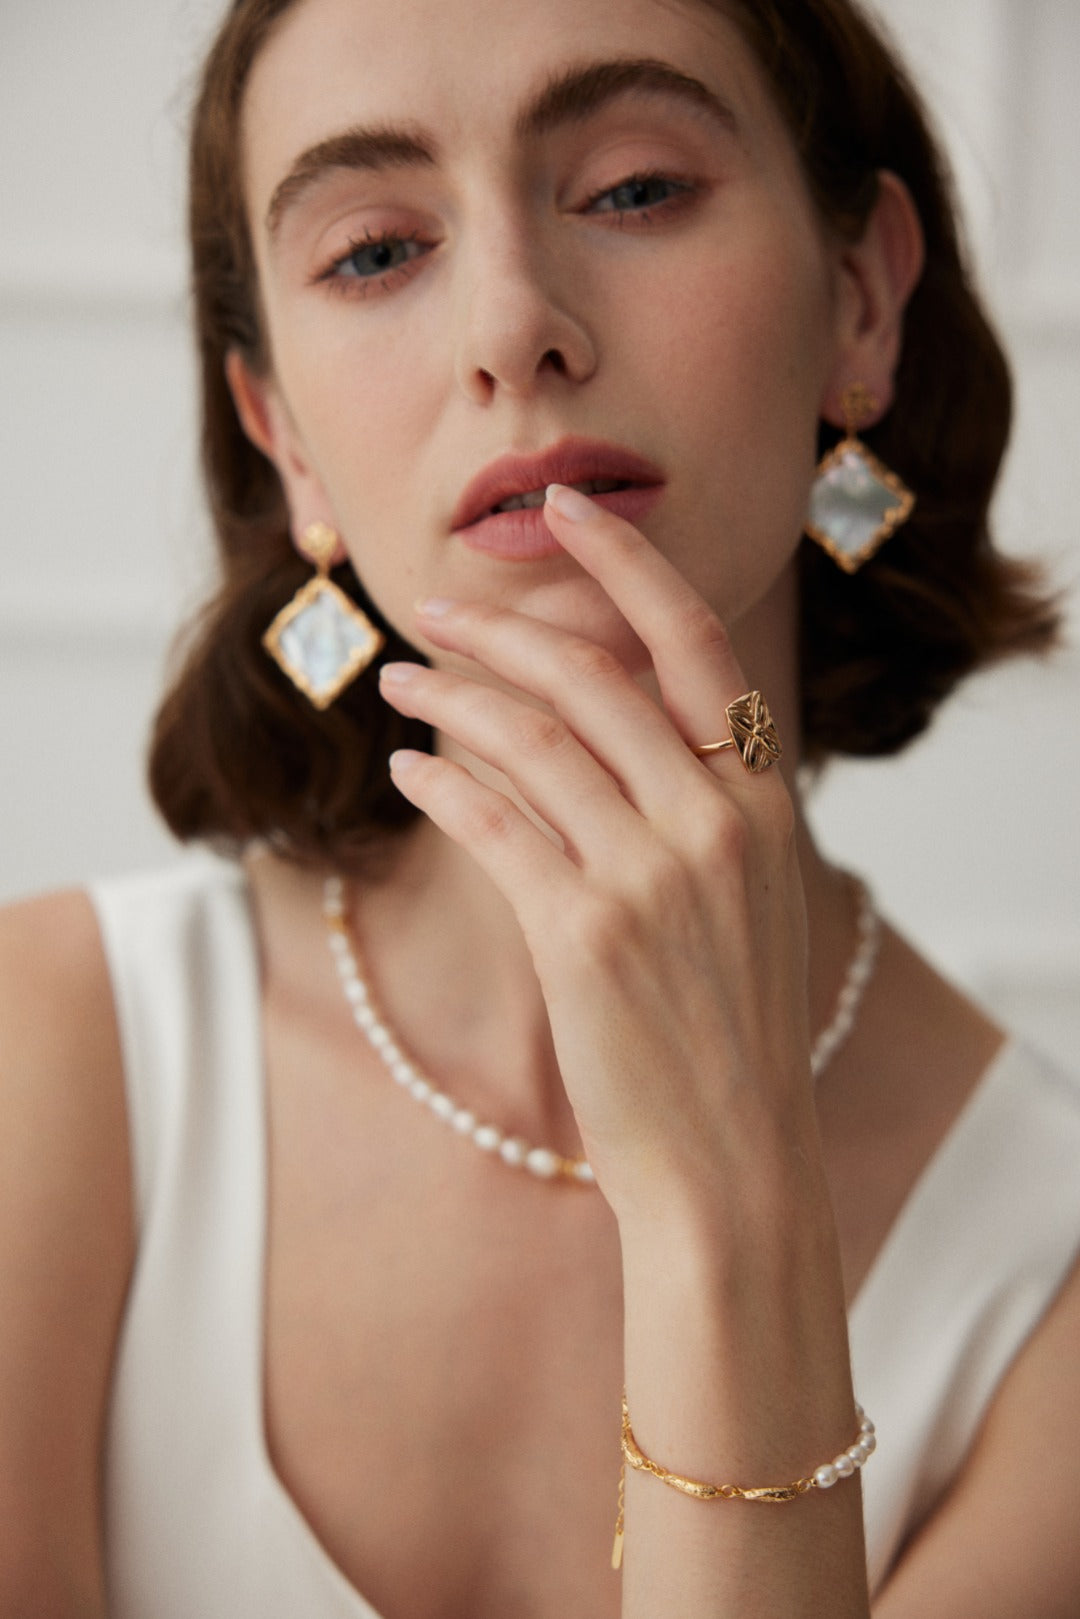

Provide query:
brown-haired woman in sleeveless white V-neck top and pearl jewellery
left=0, top=0, right=1080, bottom=1619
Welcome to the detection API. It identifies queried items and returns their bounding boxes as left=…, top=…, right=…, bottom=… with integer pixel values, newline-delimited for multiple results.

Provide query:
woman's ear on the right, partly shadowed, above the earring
left=821, top=170, right=926, bottom=427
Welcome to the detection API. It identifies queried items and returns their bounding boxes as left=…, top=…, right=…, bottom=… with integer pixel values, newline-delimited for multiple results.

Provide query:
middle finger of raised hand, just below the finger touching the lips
left=418, top=602, right=701, bottom=819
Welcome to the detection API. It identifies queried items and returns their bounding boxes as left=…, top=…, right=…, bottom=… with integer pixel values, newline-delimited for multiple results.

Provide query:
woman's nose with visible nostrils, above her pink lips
left=455, top=222, right=596, bottom=405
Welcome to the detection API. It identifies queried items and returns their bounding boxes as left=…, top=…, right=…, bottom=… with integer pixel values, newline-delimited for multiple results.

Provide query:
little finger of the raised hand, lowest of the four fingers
left=390, top=748, right=581, bottom=942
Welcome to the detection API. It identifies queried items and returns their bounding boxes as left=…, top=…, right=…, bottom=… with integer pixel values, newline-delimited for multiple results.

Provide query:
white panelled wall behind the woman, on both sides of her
left=0, top=0, right=1080, bottom=1060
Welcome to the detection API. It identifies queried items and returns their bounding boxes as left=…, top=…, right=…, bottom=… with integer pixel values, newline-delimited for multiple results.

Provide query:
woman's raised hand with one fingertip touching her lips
left=375, top=485, right=811, bottom=1213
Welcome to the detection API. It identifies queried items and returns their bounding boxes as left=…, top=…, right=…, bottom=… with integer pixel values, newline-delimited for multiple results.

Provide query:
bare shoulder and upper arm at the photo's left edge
left=0, top=892, right=134, bottom=1613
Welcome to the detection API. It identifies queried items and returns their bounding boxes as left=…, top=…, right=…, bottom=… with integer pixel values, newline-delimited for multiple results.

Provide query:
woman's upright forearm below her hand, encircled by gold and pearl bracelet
left=620, top=1146, right=873, bottom=1619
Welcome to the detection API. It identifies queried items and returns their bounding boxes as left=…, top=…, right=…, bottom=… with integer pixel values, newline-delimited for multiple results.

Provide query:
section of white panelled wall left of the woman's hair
left=0, top=0, right=220, bottom=895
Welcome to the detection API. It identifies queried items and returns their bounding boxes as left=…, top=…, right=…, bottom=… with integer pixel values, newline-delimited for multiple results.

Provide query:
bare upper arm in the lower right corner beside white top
left=874, top=1243, right=1080, bottom=1619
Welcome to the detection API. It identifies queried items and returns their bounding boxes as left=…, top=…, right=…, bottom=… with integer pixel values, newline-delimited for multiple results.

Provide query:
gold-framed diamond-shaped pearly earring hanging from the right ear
left=806, top=382, right=915, bottom=573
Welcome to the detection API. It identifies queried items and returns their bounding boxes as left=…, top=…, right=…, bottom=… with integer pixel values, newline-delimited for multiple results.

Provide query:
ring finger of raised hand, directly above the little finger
left=379, top=664, right=644, bottom=871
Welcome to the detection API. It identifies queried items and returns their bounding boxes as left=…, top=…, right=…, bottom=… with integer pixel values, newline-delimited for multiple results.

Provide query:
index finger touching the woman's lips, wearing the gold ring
left=544, top=484, right=780, bottom=780
